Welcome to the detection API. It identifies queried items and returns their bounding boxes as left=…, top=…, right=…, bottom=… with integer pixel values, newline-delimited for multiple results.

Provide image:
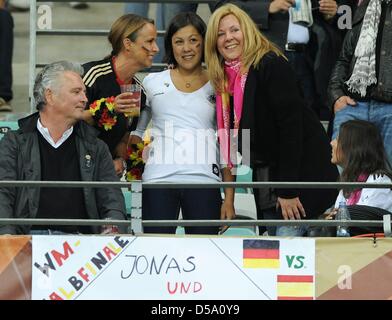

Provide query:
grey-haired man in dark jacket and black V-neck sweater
left=0, top=61, right=126, bottom=234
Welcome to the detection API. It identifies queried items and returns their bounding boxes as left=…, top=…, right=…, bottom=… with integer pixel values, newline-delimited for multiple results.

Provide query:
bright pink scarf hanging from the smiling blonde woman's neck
left=216, top=60, right=248, bottom=169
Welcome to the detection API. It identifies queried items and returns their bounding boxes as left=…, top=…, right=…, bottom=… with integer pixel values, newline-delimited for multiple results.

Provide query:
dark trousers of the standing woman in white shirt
left=142, top=189, right=222, bottom=234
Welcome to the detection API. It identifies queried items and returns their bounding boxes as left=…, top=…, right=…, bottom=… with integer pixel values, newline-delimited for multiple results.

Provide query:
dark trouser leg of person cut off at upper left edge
left=0, top=9, right=14, bottom=101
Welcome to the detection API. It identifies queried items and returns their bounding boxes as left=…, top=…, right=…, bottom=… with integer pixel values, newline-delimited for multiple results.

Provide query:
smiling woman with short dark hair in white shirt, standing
left=131, top=12, right=234, bottom=234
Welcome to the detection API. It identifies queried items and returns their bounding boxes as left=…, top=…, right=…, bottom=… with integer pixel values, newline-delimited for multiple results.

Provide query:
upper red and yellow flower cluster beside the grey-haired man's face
left=89, top=97, right=117, bottom=131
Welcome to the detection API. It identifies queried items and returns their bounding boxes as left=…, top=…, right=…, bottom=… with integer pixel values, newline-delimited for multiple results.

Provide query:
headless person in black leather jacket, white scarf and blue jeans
left=329, top=0, right=392, bottom=162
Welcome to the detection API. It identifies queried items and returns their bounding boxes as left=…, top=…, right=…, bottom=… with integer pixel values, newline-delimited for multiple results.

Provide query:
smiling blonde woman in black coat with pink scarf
left=205, top=4, right=338, bottom=236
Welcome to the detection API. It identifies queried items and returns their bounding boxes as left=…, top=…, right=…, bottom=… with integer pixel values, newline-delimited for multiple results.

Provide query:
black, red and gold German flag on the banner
left=243, top=240, right=280, bottom=269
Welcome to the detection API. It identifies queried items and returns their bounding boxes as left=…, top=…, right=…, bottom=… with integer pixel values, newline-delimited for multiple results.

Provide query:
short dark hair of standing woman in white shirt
left=163, top=12, right=207, bottom=66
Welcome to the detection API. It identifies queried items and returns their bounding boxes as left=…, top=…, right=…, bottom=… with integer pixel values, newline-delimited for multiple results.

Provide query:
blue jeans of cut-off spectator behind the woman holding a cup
left=124, top=3, right=165, bottom=63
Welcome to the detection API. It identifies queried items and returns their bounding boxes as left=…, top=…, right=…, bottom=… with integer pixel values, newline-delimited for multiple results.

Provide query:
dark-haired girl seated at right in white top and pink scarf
left=331, top=120, right=392, bottom=212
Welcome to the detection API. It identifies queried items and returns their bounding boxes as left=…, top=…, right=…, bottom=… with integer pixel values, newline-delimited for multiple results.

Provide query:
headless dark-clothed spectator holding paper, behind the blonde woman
left=217, top=0, right=342, bottom=120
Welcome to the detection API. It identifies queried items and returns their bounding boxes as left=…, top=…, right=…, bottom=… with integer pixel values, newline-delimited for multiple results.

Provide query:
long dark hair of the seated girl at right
left=337, top=120, right=392, bottom=193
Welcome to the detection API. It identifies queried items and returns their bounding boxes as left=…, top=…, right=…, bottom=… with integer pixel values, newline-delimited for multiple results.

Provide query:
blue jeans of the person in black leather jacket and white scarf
left=332, top=100, right=392, bottom=162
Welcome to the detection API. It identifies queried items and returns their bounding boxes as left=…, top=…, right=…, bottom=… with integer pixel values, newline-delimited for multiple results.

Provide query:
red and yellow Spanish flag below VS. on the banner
left=277, top=275, right=314, bottom=300
